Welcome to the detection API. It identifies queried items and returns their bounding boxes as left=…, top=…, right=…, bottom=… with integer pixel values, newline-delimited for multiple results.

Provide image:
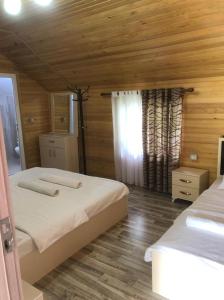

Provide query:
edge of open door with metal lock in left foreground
left=0, top=113, right=22, bottom=300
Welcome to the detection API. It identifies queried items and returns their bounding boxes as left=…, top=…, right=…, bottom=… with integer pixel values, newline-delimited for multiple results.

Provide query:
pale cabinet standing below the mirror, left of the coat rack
left=39, top=133, right=79, bottom=172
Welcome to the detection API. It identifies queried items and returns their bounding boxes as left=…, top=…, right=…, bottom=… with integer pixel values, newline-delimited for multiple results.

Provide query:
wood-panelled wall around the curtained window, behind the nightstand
left=85, top=77, right=224, bottom=183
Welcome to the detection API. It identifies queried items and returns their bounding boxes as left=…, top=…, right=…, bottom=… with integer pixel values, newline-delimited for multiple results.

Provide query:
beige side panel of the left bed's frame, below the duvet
left=20, top=196, right=128, bottom=284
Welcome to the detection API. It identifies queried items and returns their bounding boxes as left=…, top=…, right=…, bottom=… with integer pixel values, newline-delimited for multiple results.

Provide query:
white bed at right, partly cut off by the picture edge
left=145, top=139, right=224, bottom=300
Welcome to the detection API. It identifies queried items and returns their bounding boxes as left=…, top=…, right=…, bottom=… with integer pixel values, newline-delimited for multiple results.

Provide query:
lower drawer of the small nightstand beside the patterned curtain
left=172, top=185, right=199, bottom=202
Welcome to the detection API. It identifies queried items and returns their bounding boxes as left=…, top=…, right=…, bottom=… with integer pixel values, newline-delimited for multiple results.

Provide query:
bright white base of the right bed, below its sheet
left=152, top=250, right=224, bottom=300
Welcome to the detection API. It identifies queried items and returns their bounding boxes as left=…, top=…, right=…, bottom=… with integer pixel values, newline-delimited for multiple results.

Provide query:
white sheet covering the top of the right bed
left=145, top=179, right=224, bottom=264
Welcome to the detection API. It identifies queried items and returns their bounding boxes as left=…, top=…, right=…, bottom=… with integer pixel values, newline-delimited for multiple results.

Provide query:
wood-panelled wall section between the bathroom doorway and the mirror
left=0, top=55, right=50, bottom=168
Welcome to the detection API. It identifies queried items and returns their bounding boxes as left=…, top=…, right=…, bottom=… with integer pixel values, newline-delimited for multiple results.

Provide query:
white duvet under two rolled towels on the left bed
left=10, top=168, right=128, bottom=252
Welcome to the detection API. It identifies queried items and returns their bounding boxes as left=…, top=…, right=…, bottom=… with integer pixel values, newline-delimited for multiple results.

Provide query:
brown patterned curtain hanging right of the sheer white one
left=142, top=88, right=184, bottom=193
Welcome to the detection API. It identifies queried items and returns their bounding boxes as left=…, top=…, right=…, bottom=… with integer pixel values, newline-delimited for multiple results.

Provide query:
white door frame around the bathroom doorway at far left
left=0, top=73, right=26, bottom=170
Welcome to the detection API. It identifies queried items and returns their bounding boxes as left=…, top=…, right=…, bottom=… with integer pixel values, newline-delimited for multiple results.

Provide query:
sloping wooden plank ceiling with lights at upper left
left=0, top=0, right=224, bottom=90
